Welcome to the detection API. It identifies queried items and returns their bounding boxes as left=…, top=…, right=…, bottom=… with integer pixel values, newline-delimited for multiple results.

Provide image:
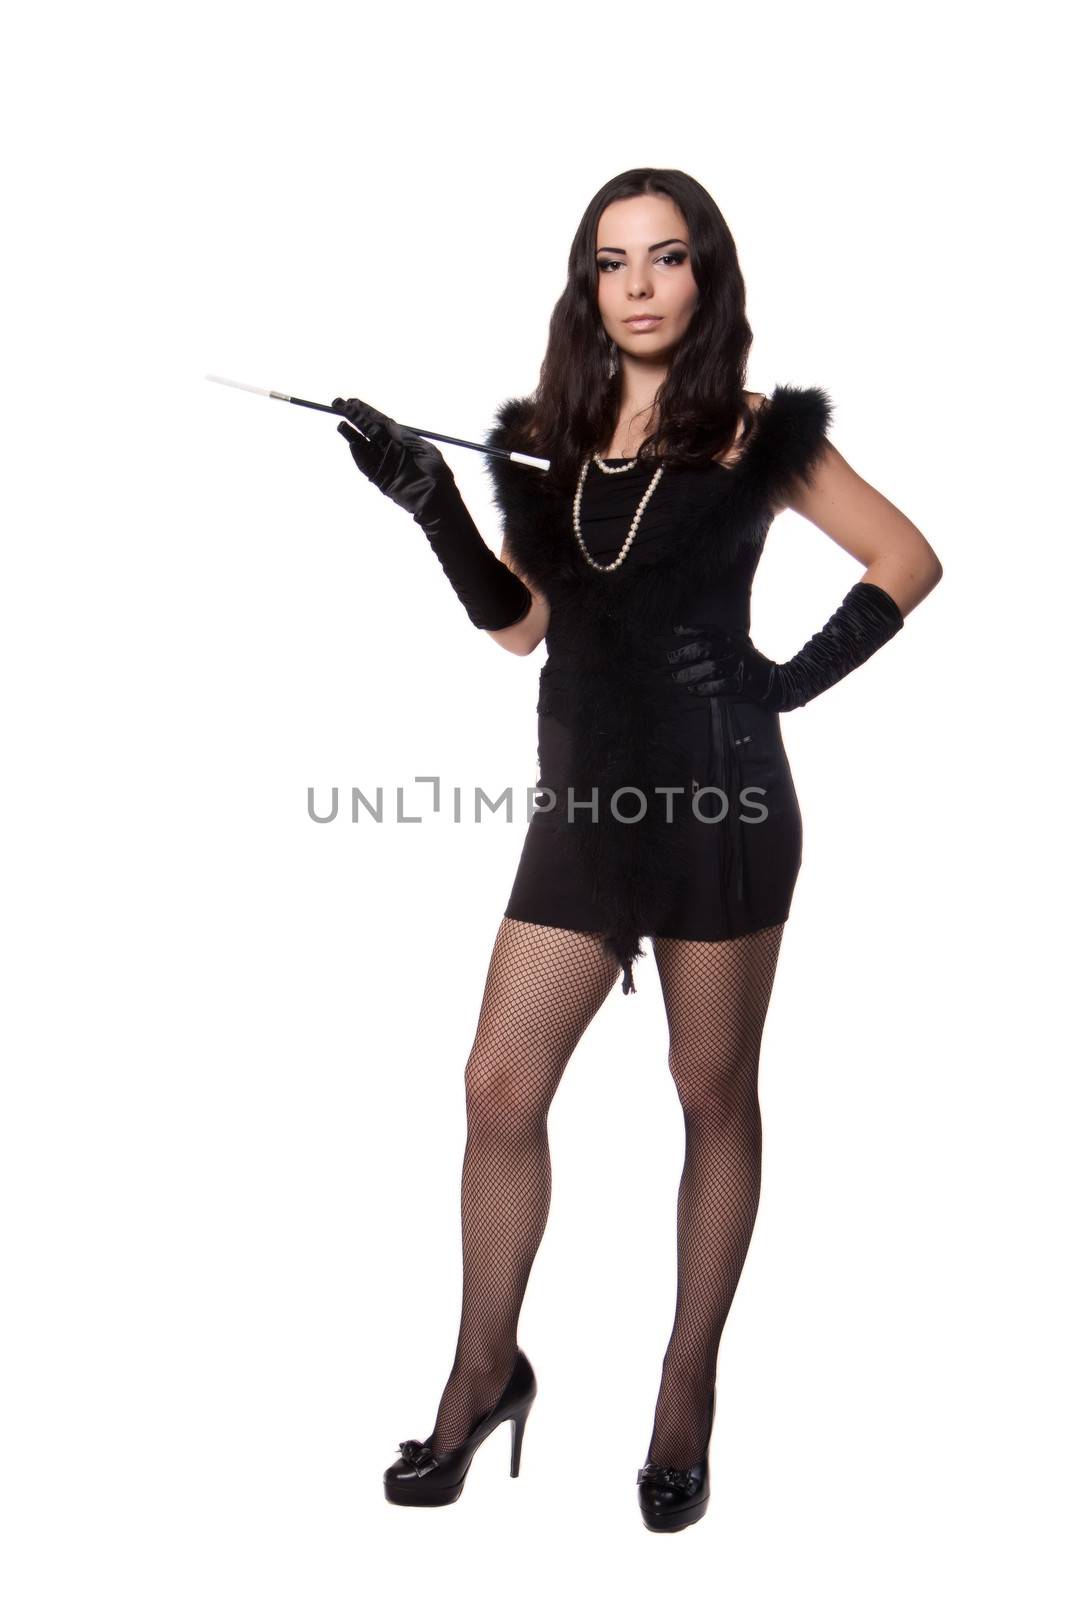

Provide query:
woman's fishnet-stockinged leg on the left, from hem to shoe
left=427, top=917, right=619, bottom=1451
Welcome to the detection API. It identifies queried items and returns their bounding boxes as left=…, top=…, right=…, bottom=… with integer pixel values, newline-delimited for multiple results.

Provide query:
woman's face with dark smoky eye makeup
left=597, top=195, right=699, bottom=362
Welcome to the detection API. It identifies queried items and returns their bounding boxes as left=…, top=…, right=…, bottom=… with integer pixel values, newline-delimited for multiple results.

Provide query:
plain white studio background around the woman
left=0, top=0, right=1067, bottom=1600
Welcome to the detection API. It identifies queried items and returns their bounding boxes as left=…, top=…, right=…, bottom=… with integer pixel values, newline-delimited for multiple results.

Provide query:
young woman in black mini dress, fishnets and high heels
left=334, top=168, right=941, bottom=1531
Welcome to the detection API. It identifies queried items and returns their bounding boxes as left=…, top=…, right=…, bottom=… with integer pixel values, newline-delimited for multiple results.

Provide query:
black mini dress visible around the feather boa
left=506, top=458, right=801, bottom=939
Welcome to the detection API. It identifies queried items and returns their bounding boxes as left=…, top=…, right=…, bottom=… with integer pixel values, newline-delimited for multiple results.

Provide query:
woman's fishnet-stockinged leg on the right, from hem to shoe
left=648, top=923, right=784, bottom=1469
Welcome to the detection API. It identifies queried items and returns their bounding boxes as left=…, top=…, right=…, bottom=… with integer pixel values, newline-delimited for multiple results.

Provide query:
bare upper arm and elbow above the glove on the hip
left=777, top=442, right=942, bottom=616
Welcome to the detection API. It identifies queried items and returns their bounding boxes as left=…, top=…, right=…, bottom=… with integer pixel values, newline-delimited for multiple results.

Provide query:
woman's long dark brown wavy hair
left=523, top=166, right=752, bottom=488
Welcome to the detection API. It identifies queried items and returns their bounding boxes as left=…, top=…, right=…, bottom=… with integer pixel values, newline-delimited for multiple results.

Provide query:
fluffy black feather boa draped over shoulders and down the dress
left=485, top=384, right=833, bottom=994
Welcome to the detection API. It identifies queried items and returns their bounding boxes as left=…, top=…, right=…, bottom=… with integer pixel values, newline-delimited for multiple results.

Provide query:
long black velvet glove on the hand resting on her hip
left=667, top=579, right=904, bottom=710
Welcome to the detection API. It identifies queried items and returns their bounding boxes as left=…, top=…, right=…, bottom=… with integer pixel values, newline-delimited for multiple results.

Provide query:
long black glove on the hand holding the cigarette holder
left=333, top=398, right=533, bottom=632
